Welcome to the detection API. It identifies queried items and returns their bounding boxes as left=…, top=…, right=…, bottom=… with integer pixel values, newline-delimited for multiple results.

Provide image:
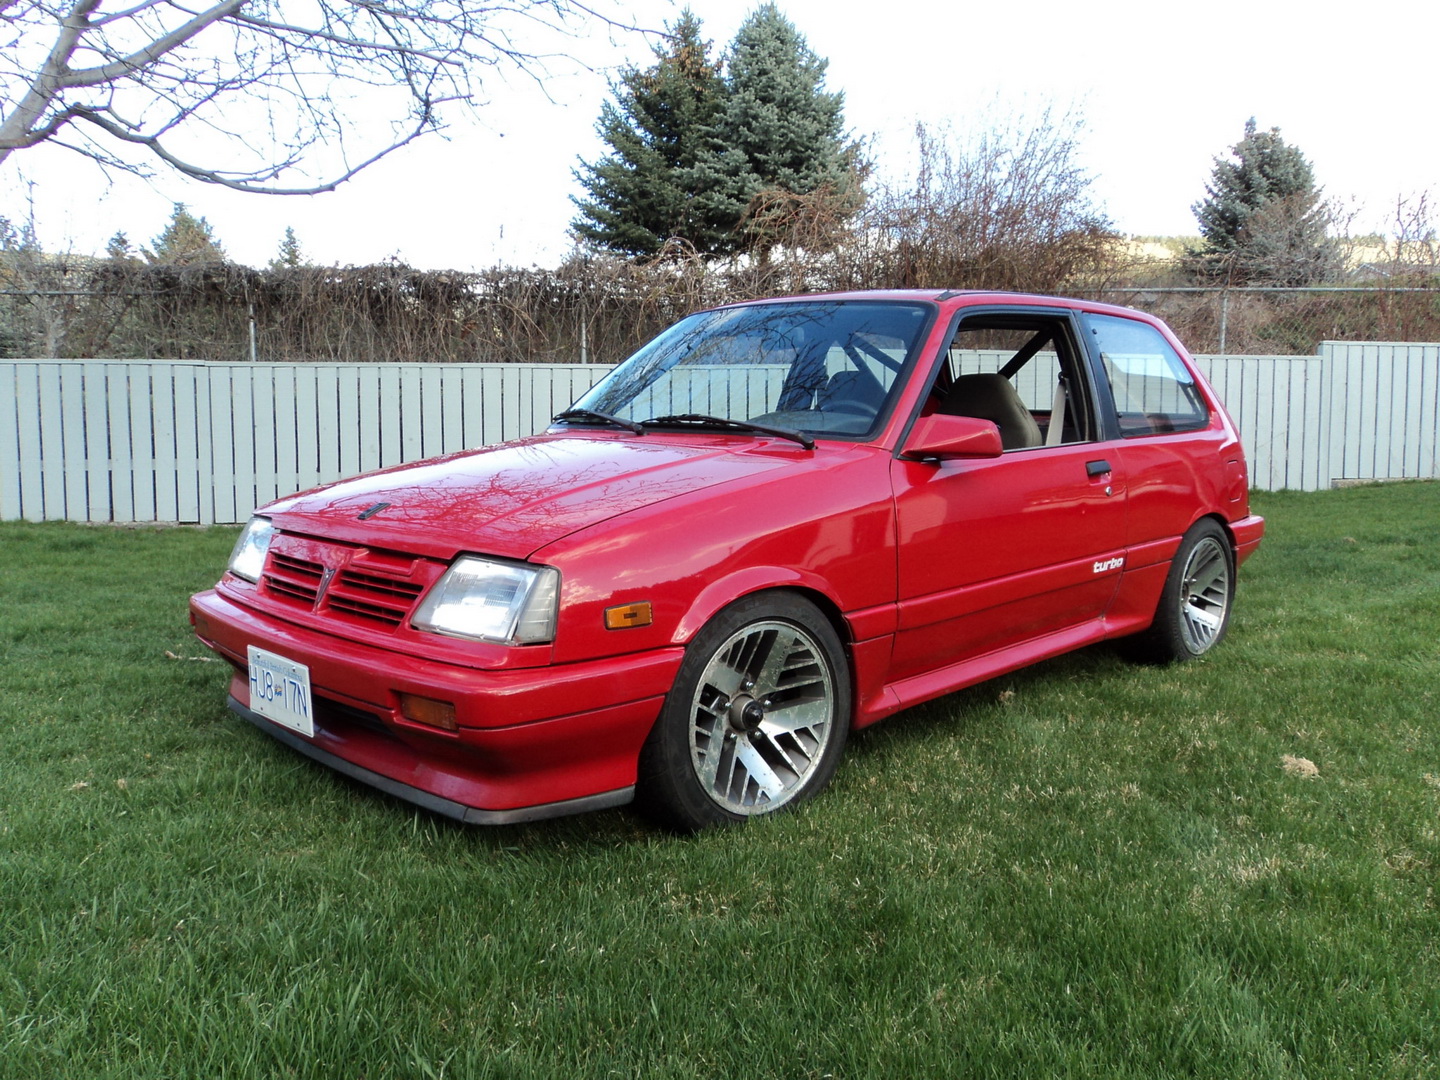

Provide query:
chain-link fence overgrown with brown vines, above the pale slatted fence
left=0, top=259, right=1440, bottom=364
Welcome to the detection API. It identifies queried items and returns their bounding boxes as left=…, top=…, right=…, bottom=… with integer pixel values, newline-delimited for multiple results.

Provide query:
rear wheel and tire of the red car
left=1132, top=517, right=1236, bottom=664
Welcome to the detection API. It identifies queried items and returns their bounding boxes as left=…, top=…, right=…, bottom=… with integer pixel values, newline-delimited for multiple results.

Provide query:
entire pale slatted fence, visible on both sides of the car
left=0, top=343, right=1440, bottom=524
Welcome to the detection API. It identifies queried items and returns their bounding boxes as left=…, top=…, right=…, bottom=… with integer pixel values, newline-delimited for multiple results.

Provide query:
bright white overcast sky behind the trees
left=0, top=0, right=1440, bottom=269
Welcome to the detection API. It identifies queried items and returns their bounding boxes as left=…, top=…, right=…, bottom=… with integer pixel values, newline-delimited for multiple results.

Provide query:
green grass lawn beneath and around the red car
left=0, top=484, right=1440, bottom=1080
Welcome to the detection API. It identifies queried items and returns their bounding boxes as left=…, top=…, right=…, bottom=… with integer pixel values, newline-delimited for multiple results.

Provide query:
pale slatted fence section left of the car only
left=0, top=360, right=606, bottom=524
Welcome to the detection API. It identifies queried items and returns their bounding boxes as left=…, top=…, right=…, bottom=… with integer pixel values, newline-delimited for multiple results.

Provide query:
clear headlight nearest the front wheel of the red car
left=410, top=556, right=560, bottom=645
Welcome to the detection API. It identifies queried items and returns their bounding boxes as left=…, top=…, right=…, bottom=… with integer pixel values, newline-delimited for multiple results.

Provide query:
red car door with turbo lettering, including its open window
left=891, top=310, right=1126, bottom=681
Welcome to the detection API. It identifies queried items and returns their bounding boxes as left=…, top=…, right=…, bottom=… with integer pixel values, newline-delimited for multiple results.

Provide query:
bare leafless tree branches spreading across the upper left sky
left=0, top=0, right=636, bottom=194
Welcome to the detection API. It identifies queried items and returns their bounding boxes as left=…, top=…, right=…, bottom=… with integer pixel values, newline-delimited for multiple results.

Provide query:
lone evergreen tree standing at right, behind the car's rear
left=1192, top=117, right=1336, bottom=285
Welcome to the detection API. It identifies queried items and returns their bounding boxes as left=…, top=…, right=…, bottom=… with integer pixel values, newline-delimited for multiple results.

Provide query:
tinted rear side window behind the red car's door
left=1086, top=315, right=1210, bottom=436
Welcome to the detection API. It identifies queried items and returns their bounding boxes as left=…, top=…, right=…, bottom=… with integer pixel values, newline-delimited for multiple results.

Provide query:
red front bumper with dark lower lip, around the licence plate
left=190, top=590, right=684, bottom=824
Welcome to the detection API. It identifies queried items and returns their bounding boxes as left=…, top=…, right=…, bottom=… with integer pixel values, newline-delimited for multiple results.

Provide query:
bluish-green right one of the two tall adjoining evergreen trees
left=696, top=4, right=860, bottom=258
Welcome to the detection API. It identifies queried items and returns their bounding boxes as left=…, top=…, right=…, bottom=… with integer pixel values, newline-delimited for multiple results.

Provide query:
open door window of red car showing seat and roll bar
left=935, top=314, right=1096, bottom=451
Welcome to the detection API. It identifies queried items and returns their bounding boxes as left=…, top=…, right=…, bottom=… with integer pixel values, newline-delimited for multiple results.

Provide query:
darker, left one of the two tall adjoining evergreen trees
left=572, top=9, right=736, bottom=255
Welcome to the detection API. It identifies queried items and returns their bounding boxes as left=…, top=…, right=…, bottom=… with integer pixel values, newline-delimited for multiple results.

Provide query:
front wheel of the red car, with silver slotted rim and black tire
left=636, top=592, right=851, bottom=832
